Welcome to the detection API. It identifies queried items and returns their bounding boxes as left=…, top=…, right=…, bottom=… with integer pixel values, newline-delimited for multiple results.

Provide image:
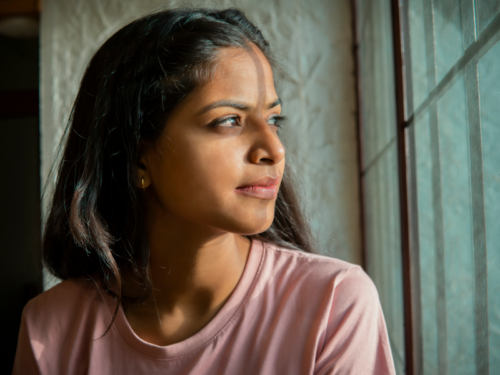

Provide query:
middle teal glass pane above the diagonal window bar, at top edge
left=432, top=0, right=464, bottom=82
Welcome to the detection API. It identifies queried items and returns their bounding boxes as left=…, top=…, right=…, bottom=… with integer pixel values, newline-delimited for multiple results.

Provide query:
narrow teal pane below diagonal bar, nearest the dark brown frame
left=414, top=113, right=438, bottom=375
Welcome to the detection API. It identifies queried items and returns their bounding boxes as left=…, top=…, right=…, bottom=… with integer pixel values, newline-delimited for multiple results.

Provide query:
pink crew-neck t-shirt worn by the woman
left=14, top=241, right=395, bottom=375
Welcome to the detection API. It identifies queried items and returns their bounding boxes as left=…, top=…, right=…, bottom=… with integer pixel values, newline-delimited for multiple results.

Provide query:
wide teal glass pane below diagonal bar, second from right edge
left=438, top=78, right=475, bottom=375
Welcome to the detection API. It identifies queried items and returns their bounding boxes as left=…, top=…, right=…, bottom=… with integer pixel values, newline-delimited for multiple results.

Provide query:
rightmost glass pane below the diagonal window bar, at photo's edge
left=478, top=38, right=500, bottom=369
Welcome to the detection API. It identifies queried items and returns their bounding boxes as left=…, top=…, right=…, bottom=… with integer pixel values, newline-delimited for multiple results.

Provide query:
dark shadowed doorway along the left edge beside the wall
left=0, top=35, right=41, bottom=374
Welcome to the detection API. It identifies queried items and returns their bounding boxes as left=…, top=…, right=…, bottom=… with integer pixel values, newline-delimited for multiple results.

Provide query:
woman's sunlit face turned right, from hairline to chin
left=141, top=46, right=285, bottom=235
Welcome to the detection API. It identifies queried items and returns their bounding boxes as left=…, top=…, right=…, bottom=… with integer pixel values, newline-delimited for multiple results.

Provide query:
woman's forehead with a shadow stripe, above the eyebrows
left=193, top=45, right=277, bottom=105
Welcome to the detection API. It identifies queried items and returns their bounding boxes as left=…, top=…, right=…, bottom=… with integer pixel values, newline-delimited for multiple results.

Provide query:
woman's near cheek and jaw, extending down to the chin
left=153, top=139, right=280, bottom=234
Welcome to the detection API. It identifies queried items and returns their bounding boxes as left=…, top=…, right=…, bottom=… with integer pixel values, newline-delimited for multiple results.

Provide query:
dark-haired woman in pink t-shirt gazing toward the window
left=14, top=9, right=394, bottom=375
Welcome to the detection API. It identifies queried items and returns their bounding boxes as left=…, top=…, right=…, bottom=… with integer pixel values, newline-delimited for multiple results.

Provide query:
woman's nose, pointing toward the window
left=249, top=120, right=285, bottom=165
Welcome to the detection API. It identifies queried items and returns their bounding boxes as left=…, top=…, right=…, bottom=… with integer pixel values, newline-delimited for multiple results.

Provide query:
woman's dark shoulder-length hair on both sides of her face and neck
left=42, top=8, right=314, bottom=301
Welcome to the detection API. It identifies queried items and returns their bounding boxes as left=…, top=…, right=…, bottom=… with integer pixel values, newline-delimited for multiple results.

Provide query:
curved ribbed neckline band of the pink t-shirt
left=109, top=239, right=264, bottom=359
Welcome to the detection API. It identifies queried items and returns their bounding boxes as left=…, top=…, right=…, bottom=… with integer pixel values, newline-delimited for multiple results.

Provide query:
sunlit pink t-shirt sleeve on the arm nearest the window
left=314, top=267, right=396, bottom=375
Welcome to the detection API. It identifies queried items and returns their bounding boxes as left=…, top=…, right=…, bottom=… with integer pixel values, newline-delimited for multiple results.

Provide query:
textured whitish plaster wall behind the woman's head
left=41, top=0, right=361, bottom=286
